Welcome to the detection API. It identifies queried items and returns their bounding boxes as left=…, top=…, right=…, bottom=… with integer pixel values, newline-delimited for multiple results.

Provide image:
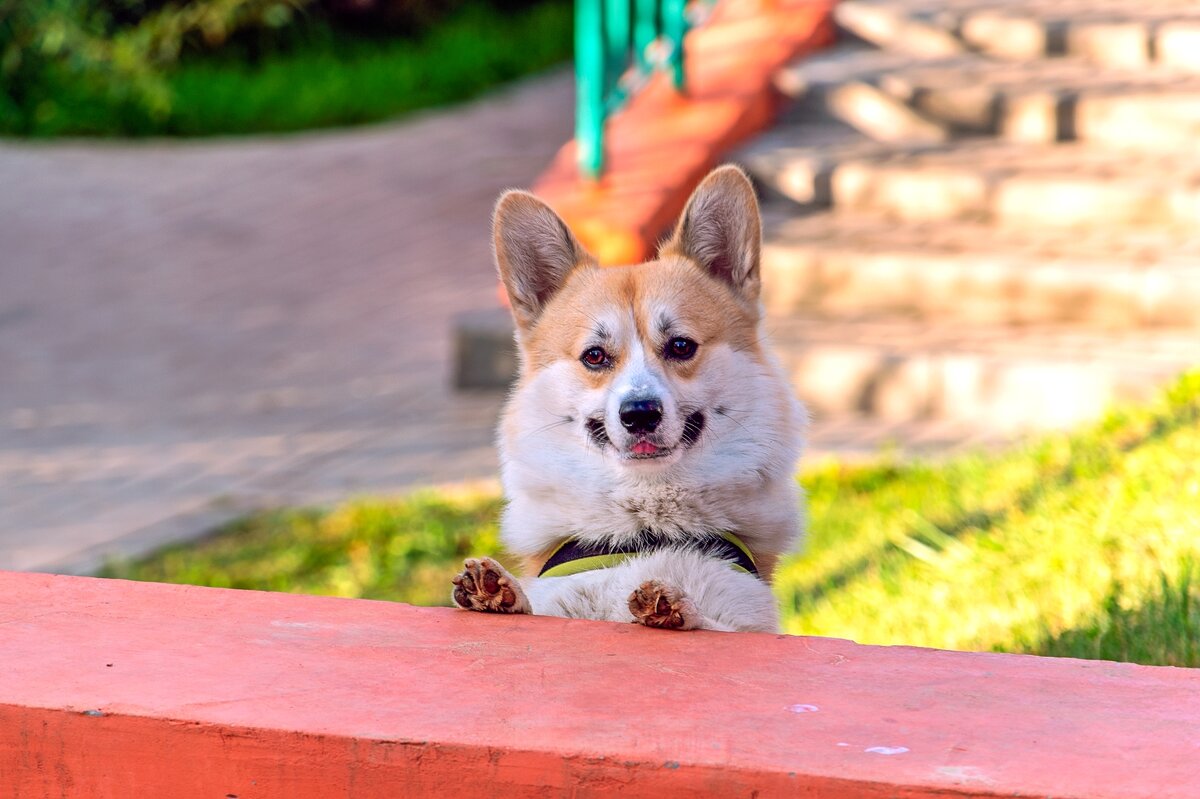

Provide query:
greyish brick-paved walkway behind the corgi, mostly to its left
left=0, top=65, right=993, bottom=571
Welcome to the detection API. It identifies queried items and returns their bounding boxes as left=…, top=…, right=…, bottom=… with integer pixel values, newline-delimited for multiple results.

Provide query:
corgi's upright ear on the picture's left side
left=492, top=191, right=594, bottom=330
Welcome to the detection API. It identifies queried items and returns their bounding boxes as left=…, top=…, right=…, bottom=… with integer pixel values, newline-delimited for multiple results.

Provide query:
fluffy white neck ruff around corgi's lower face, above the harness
left=499, top=326, right=805, bottom=558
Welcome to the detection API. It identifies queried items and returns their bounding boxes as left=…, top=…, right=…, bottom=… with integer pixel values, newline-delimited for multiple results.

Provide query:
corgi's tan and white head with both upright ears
left=493, top=167, right=791, bottom=475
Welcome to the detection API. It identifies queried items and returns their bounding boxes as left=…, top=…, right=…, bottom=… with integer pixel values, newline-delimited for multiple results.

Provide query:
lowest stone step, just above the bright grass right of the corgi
left=770, top=317, right=1200, bottom=431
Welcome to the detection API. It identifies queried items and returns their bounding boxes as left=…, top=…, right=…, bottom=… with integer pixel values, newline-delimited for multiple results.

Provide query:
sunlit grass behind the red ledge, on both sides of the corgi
left=100, top=373, right=1200, bottom=667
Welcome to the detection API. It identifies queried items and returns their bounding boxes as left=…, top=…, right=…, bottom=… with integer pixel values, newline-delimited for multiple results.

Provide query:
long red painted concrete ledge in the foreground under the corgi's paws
left=0, top=572, right=1200, bottom=799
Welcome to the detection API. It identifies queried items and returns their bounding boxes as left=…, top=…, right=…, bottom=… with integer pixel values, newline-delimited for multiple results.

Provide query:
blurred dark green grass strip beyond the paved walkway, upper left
left=163, top=1, right=571, bottom=136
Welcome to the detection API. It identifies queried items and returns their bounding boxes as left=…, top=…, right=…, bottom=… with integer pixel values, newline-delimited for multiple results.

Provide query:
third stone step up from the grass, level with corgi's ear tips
left=732, top=128, right=1200, bottom=229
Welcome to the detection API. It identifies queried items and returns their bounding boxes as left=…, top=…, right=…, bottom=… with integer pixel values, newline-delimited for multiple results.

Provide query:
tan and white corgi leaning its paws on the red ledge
left=452, top=166, right=808, bottom=631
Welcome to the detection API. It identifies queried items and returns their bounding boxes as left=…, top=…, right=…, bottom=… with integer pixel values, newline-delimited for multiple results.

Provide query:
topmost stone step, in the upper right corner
left=835, top=0, right=1200, bottom=72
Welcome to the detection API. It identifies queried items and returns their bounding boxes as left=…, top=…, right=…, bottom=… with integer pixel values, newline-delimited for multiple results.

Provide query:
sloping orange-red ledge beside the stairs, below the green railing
left=533, top=0, right=834, bottom=264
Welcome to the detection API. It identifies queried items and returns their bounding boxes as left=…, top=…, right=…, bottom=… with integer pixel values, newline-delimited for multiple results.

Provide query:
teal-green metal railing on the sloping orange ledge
left=575, top=0, right=712, bottom=180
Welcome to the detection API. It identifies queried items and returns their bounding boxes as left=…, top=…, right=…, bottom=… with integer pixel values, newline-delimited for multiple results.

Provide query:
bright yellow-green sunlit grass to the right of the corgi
left=778, top=377, right=1200, bottom=665
